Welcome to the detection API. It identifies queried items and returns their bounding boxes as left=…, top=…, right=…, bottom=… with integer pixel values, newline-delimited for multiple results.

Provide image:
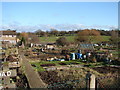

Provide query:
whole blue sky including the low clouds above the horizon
left=2, top=2, right=118, bottom=32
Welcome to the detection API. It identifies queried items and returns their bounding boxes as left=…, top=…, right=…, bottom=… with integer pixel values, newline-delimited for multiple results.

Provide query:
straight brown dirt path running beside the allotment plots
left=20, top=52, right=47, bottom=88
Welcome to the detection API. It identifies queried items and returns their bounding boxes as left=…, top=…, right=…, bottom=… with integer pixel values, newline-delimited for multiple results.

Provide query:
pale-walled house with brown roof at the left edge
left=0, top=30, right=17, bottom=44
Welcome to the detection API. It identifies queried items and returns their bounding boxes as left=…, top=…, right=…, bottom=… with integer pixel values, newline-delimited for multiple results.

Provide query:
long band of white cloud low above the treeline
left=0, top=22, right=118, bottom=32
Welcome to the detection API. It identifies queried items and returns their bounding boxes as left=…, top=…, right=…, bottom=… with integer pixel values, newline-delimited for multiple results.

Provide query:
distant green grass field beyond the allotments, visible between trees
left=39, top=36, right=110, bottom=43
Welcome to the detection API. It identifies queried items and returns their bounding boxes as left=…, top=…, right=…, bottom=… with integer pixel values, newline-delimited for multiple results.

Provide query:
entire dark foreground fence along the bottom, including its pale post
left=47, top=72, right=120, bottom=90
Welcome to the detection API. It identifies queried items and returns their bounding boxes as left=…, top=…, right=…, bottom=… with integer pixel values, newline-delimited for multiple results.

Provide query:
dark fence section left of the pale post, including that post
left=47, top=72, right=95, bottom=90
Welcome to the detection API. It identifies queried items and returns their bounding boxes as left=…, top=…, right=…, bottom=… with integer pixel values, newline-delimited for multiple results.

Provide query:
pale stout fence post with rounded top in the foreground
left=86, top=71, right=95, bottom=90
